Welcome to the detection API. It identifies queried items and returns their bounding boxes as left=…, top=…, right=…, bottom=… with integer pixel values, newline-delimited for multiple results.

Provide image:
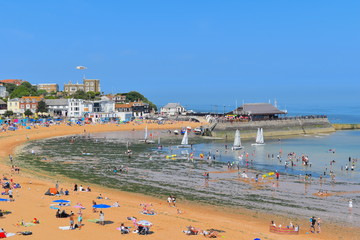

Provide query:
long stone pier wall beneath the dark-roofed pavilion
left=211, top=118, right=335, bottom=139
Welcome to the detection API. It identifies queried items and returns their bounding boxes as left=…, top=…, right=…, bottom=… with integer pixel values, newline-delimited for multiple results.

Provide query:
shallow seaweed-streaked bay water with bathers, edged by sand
left=16, top=131, right=360, bottom=226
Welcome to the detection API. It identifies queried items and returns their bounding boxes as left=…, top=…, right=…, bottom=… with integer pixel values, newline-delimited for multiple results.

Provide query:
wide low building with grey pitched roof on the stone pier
left=228, top=103, right=287, bottom=121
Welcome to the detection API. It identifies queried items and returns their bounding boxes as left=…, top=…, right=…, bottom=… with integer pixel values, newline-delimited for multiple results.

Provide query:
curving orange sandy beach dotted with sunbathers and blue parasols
left=0, top=122, right=360, bottom=240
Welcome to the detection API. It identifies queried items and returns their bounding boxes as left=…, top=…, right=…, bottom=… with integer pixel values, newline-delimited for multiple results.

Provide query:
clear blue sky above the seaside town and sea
left=0, top=0, right=360, bottom=111
